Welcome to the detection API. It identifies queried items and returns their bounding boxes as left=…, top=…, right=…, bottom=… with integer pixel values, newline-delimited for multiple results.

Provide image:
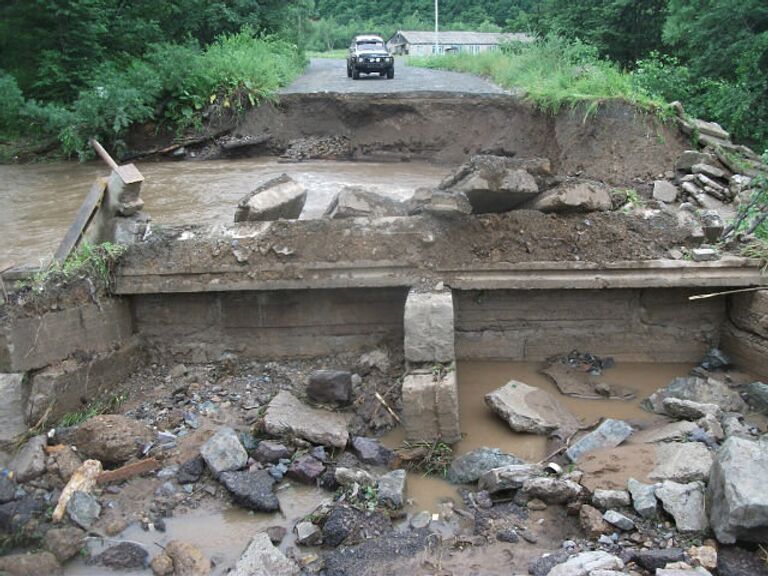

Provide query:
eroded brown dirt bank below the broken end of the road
left=233, top=93, right=685, bottom=185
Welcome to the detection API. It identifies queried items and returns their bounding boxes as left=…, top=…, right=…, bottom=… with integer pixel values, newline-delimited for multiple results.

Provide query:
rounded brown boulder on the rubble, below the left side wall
left=74, top=414, right=154, bottom=465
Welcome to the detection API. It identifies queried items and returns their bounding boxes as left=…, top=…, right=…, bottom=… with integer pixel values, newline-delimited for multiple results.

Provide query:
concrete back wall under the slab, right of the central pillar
left=454, top=289, right=726, bottom=362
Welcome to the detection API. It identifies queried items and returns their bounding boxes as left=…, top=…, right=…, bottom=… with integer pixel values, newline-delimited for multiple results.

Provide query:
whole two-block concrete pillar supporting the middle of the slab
left=402, top=290, right=461, bottom=444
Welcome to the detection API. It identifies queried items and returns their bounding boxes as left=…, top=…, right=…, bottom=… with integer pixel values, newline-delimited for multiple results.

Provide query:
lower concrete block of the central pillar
left=402, top=369, right=461, bottom=444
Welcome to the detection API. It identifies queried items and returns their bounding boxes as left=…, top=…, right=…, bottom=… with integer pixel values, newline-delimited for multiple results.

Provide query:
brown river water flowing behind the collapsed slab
left=0, top=158, right=447, bottom=270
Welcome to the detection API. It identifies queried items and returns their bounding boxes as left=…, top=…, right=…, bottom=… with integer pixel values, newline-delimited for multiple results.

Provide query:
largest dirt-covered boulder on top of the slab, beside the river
left=440, top=155, right=551, bottom=214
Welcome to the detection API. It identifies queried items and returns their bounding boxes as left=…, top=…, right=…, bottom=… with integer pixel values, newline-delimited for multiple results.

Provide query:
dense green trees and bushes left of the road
left=0, top=0, right=304, bottom=156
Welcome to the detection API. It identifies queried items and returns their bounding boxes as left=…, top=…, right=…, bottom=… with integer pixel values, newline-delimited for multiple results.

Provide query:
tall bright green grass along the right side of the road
left=408, top=36, right=664, bottom=113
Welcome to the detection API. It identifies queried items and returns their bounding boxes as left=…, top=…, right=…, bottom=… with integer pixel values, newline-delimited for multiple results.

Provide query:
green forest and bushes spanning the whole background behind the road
left=0, top=0, right=768, bottom=155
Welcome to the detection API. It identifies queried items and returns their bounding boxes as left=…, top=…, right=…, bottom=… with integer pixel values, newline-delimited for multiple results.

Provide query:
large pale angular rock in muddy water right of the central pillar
left=485, top=380, right=581, bottom=438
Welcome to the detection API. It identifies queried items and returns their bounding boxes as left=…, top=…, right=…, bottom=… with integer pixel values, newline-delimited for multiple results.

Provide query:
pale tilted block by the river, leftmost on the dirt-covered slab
left=235, top=174, right=307, bottom=222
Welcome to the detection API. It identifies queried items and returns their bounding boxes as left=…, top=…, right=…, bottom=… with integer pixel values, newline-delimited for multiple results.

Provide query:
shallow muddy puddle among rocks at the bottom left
left=64, top=484, right=331, bottom=576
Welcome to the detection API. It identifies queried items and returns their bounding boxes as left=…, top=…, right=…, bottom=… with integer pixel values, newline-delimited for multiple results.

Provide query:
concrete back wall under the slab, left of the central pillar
left=133, top=288, right=407, bottom=362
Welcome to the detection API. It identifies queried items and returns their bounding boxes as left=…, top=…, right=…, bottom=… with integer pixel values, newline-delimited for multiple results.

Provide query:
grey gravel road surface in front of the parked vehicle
left=280, top=58, right=504, bottom=94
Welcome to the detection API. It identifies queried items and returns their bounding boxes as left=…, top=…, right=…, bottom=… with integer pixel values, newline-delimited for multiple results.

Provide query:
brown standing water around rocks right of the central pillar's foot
left=384, top=362, right=692, bottom=511
